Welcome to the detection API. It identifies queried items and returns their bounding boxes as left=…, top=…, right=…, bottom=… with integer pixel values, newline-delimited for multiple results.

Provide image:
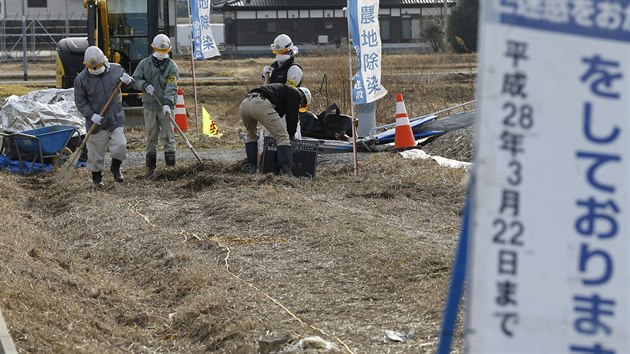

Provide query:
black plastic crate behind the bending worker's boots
left=261, top=136, right=319, bottom=178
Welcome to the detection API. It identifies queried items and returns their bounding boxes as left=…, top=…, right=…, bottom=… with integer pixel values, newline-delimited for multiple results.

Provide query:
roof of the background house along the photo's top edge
left=214, top=0, right=456, bottom=11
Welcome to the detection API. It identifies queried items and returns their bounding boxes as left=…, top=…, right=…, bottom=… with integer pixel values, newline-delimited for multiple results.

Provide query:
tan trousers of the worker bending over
left=240, top=95, right=291, bottom=146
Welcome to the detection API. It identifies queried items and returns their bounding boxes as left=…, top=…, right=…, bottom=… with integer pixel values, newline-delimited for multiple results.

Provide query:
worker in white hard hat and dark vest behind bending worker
left=262, top=34, right=304, bottom=87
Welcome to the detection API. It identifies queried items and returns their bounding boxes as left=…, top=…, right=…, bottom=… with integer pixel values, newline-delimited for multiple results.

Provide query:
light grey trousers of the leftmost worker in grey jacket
left=86, top=127, right=127, bottom=172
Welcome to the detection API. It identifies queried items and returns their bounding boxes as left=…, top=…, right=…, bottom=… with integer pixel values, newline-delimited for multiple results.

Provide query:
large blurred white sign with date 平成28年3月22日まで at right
left=465, top=0, right=630, bottom=354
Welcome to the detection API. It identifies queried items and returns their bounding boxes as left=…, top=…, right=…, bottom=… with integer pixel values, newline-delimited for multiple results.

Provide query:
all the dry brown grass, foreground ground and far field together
left=0, top=54, right=475, bottom=354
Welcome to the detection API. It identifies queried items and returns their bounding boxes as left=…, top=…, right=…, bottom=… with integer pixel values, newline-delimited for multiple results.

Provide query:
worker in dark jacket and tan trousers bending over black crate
left=240, top=84, right=312, bottom=175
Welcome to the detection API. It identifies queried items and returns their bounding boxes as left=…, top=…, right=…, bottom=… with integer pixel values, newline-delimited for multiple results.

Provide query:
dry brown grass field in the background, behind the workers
left=0, top=51, right=476, bottom=137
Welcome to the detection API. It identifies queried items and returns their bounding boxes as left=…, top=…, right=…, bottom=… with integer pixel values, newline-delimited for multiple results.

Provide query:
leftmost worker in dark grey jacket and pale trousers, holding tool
left=74, top=46, right=132, bottom=187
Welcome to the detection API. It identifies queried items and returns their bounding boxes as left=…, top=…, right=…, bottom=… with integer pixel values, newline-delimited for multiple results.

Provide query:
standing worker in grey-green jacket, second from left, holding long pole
left=133, top=34, right=179, bottom=177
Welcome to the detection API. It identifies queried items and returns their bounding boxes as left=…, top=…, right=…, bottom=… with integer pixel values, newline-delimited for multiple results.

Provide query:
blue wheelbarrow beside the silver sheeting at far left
left=0, top=125, right=77, bottom=173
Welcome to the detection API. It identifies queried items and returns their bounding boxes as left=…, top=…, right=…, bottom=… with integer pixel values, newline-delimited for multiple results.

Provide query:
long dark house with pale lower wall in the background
left=213, top=0, right=456, bottom=53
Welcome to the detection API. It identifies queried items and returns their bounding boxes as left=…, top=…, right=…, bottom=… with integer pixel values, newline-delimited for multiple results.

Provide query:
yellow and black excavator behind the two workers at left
left=56, top=0, right=176, bottom=126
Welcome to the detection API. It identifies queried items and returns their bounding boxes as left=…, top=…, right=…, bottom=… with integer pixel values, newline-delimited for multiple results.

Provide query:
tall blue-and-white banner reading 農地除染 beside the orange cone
left=348, top=0, right=387, bottom=104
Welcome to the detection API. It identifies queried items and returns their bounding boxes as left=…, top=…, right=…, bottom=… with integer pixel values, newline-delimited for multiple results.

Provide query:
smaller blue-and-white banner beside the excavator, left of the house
left=190, top=0, right=221, bottom=59
